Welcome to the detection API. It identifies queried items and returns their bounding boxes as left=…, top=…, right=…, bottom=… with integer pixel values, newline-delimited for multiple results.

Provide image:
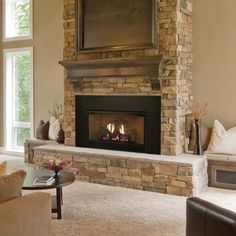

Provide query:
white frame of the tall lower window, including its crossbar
left=3, top=47, right=34, bottom=153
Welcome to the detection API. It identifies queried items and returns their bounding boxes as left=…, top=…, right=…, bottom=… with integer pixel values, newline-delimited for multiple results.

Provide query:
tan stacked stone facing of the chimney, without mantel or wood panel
left=64, top=0, right=192, bottom=155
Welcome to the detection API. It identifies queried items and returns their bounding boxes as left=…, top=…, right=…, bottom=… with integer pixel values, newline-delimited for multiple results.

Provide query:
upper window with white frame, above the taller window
left=3, top=0, right=32, bottom=41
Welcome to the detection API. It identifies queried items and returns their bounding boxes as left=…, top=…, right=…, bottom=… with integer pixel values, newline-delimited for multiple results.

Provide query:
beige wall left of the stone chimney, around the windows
left=0, top=0, right=64, bottom=146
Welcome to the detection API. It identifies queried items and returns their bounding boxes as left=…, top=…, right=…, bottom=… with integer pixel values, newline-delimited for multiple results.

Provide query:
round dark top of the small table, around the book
left=22, top=169, right=75, bottom=190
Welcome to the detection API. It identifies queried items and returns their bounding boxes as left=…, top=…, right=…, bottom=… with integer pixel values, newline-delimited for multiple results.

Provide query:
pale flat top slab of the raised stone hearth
left=34, top=145, right=205, bottom=166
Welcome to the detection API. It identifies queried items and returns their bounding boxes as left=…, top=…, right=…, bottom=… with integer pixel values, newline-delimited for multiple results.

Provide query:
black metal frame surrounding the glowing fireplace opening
left=75, top=95, right=161, bottom=154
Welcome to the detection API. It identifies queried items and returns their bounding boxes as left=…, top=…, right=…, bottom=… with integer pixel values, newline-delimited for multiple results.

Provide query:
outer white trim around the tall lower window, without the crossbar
left=3, top=47, right=34, bottom=151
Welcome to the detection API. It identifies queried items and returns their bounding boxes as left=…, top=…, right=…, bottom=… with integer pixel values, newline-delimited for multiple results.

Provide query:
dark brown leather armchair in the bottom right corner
left=186, top=198, right=236, bottom=236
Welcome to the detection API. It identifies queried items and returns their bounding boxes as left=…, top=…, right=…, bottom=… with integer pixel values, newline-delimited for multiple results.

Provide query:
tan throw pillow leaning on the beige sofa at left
left=0, top=170, right=26, bottom=203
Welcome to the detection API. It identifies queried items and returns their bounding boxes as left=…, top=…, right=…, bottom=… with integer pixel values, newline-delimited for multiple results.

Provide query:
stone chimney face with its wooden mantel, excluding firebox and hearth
left=60, top=0, right=192, bottom=155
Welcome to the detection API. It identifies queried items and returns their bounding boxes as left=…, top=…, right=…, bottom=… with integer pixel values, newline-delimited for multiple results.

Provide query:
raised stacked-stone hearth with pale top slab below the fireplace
left=34, top=145, right=208, bottom=196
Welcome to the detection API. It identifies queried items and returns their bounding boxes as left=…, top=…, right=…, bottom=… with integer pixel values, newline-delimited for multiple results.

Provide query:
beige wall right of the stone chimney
left=193, top=0, right=236, bottom=128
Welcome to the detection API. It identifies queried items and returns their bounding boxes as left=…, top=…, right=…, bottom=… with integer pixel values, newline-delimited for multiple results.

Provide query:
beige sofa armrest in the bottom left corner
left=0, top=192, right=51, bottom=236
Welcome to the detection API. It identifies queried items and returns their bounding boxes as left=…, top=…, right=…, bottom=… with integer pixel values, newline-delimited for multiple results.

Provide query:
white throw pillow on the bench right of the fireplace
left=207, top=120, right=236, bottom=154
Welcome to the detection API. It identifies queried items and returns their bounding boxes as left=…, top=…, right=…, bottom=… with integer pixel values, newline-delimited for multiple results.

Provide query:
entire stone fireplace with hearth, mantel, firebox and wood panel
left=28, top=0, right=207, bottom=199
